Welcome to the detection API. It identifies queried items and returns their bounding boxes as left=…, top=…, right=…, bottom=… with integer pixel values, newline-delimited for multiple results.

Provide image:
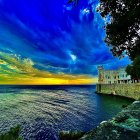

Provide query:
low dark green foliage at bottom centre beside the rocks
left=59, top=131, right=85, bottom=140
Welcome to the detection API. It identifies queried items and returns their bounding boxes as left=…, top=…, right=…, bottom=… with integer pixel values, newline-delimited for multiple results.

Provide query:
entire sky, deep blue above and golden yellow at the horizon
left=0, top=0, right=130, bottom=85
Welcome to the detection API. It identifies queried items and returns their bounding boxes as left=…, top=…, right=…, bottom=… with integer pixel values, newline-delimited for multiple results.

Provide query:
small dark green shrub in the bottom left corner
left=0, top=125, right=22, bottom=140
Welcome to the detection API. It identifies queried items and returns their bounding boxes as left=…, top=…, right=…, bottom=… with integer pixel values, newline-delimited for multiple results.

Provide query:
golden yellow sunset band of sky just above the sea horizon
left=0, top=53, right=97, bottom=85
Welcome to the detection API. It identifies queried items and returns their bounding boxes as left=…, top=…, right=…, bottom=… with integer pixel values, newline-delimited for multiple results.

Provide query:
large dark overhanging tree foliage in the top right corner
left=97, top=0, right=140, bottom=60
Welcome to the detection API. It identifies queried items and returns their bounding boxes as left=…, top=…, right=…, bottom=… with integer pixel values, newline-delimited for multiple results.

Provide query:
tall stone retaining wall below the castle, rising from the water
left=96, top=83, right=140, bottom=100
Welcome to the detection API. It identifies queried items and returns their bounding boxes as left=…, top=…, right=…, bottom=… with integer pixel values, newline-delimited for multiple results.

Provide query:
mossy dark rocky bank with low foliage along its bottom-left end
left=60, top=101, right=140, bottom=140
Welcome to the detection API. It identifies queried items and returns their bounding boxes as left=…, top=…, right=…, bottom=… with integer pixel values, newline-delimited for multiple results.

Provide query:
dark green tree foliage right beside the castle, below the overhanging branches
left=126, top=56, right=140, bottom=79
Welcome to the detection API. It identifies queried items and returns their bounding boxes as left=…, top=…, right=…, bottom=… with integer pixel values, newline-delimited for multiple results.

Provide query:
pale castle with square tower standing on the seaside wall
left=98, top=66, right=132, bottom=84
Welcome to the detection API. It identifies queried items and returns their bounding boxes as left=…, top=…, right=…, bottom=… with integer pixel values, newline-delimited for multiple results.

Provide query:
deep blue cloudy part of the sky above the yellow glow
left=0, top=0, right=130, bottom=75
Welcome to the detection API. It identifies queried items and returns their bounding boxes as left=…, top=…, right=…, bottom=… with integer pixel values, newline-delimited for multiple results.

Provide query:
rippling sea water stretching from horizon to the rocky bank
left=0, top=85, right=132, bottom=140
